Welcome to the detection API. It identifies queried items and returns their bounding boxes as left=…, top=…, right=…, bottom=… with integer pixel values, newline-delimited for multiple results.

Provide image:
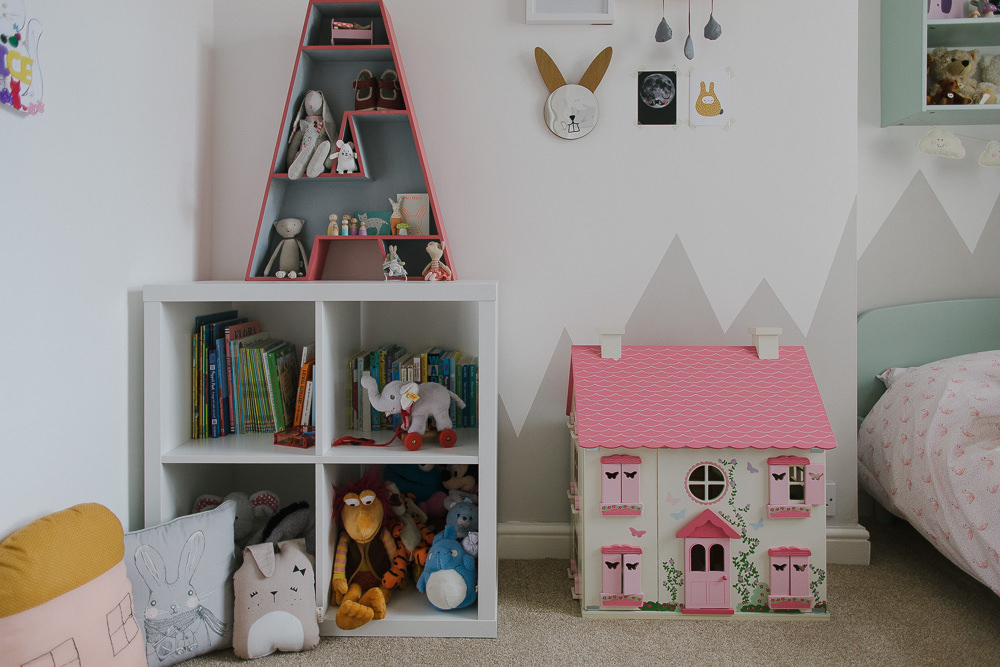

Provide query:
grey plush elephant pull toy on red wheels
left=361, top=376, right=465, bottom=452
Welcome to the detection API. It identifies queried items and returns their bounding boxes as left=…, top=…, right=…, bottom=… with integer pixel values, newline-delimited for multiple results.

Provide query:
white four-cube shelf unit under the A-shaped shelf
left=143, top=281, right=498, bottom=637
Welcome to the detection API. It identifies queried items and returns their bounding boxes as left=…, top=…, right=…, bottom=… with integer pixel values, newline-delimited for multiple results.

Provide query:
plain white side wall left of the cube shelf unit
left=0, top=0, right=212, bottom=537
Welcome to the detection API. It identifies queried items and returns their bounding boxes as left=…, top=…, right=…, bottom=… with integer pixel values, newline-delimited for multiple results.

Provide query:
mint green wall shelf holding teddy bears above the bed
left=881, top=0, right=1000, bottom=127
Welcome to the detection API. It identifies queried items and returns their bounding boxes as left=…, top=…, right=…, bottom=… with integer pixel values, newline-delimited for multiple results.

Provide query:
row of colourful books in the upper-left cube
left=191, top=310, right=315, bottom=439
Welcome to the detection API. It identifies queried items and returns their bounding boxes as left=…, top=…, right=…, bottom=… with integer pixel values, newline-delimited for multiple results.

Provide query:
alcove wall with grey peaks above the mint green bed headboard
left=857, top=2, right=1000, bottom=312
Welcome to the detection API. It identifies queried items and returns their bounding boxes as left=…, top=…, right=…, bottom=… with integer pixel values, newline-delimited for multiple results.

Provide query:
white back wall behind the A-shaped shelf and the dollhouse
left=212, top=0, right=858, bottom=544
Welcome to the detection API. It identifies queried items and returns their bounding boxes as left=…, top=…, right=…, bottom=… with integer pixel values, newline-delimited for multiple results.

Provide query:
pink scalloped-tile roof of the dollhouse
left=567, top=345, right=837, bottom=450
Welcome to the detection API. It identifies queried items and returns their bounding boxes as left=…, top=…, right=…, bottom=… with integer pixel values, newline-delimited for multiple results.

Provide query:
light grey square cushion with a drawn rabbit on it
left=125, top=500, right=236, bottom=667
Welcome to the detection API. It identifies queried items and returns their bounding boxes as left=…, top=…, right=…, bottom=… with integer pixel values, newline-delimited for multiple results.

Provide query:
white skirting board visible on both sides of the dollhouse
left=497, top=521, right=871, bottom=565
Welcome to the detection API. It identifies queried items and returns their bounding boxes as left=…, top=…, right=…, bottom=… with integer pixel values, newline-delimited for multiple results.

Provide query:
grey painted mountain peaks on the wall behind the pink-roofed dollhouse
left=498, top=224, right=856, bottom=523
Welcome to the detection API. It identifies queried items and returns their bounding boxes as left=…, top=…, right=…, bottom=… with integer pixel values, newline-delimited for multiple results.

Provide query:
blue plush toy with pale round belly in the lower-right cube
left=417, top=525, right=477, bottom=611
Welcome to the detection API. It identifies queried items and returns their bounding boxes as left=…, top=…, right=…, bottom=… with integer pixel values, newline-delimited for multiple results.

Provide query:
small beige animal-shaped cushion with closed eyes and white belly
left=233, top=539, right=319, bottom=660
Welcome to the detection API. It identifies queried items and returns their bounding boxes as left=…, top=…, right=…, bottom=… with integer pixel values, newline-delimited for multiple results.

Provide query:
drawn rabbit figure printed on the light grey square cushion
left=135, top=530, right=228, bottom=666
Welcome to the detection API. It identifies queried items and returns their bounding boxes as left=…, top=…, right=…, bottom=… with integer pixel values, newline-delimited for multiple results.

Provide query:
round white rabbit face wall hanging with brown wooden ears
left=535, top=46, right=611, bottom=139
